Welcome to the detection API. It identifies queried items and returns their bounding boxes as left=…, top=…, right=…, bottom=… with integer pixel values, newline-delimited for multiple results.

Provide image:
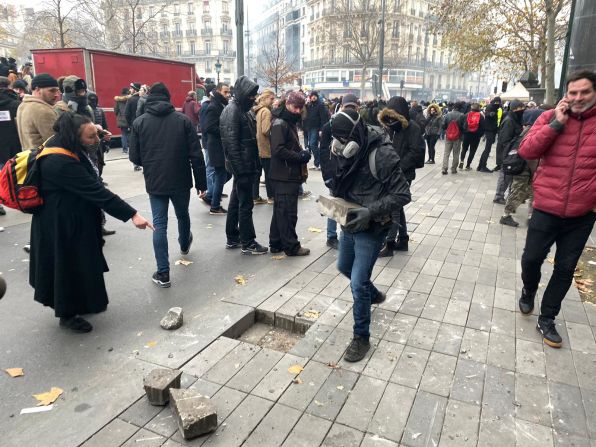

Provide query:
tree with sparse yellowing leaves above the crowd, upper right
left=433, top=0, right=570, bottom=101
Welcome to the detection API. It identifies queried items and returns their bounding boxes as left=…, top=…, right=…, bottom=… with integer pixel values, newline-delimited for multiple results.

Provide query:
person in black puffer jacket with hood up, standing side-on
left=219, top=76, right=269, bottom=255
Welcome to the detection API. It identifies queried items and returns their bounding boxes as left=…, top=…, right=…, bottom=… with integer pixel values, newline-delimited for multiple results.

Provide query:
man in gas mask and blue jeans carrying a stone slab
left=329, top=109, right=411, bottom=362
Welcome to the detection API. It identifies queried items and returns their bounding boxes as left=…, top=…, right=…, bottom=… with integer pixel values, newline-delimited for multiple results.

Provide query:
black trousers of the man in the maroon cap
left=269, top=182, right=300, bottom=254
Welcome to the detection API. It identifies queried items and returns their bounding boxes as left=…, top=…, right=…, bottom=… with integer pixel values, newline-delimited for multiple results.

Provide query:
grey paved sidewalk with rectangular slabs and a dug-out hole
left=84, top=146, right=596, bottom=447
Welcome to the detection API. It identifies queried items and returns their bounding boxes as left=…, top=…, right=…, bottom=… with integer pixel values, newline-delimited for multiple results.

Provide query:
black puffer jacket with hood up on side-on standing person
left=218, top=76, right=261, bottom=177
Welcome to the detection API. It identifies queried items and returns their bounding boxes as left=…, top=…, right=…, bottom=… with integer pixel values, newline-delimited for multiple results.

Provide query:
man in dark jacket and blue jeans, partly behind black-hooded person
left=201, top=82, right=230, bottom=216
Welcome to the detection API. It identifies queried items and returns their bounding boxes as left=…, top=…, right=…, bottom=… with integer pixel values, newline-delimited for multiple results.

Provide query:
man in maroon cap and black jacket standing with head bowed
left=269, top=92, right=310, bottom=256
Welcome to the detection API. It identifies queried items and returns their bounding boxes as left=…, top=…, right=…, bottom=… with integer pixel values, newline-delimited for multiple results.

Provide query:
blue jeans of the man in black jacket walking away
left=149, top=190, right=190, bottom=273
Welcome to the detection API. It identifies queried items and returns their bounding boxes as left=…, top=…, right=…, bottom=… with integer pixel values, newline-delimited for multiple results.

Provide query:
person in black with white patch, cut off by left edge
left=0, top=76, right=21, bottom=216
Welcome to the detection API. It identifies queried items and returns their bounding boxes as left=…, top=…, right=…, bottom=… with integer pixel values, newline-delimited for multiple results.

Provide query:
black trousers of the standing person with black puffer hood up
left=226, top=175, right=256, bottom=246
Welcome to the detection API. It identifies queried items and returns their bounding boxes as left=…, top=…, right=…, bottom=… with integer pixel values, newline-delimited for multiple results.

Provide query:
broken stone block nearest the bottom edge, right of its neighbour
left=170, top=388, right=217, bottom=439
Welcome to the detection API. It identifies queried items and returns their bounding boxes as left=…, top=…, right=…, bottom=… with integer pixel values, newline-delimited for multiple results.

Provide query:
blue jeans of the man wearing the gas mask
left=337, top=231, right=387, bottom=340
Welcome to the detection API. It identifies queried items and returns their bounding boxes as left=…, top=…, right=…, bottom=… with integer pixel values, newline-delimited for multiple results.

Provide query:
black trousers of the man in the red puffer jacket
left=522, top=210, right=596, bottom=318
